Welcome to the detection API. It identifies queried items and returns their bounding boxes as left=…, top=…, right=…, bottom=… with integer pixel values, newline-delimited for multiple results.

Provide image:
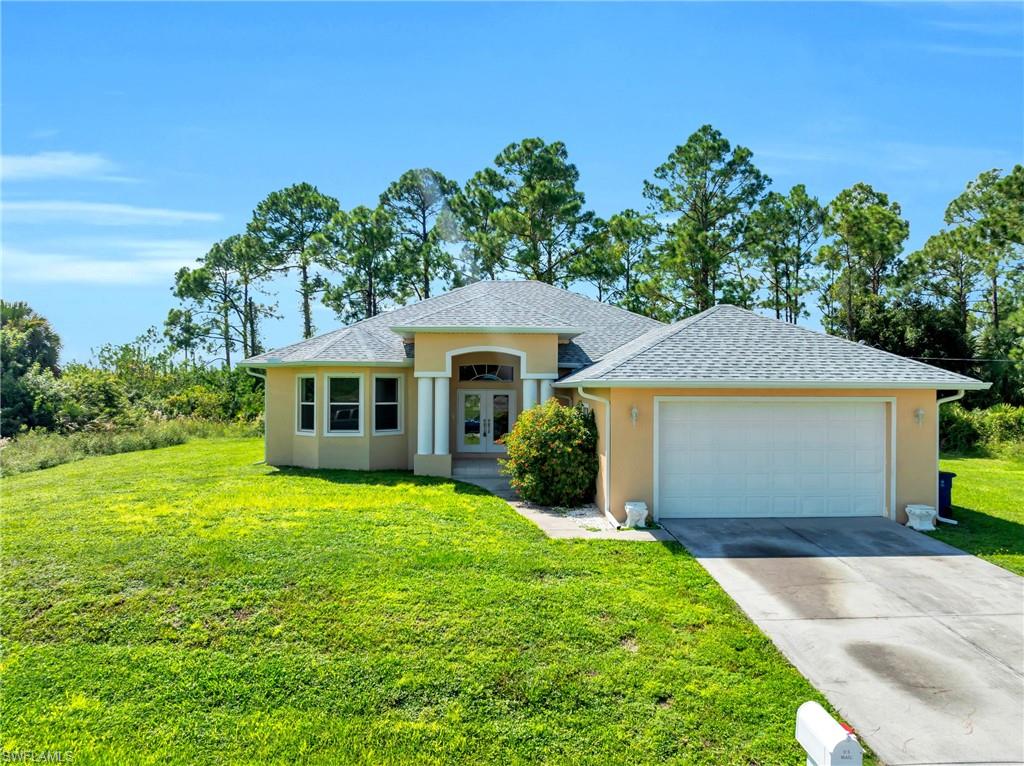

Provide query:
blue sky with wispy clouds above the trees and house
left=2, top=3, right=1024, bottom=359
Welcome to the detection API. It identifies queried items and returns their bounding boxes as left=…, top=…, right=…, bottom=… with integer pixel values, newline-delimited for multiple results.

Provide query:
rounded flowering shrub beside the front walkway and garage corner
left=502, top=399, right=597, bottom=506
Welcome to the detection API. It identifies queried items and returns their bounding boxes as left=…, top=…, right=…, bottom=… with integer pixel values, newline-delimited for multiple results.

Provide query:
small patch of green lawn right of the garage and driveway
left=934, top=456, right=1024, bottom=575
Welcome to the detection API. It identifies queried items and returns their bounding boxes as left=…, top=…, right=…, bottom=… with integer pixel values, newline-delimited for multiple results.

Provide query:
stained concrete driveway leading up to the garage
left=662, top=518, right=1024, bottom=766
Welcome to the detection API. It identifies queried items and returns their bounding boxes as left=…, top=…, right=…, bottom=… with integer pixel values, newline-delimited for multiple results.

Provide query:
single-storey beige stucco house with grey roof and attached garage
left=242, top=282, right=989, bottom=520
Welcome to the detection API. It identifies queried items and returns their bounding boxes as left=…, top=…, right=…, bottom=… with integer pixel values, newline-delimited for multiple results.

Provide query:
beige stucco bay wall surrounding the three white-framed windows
left=266, top=367, right=416, bottom=470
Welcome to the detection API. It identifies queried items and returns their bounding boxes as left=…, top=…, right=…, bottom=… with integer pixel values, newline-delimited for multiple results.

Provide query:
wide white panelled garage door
left=655, top=399, right=886, bottom=518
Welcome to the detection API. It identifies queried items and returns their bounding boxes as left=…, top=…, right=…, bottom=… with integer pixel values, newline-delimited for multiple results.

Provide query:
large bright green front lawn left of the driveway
left=0, top=439, right=839, bottom=765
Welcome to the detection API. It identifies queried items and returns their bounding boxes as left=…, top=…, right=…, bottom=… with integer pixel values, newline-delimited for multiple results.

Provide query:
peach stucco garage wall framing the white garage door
left=586, top=388, right=938, bottom=520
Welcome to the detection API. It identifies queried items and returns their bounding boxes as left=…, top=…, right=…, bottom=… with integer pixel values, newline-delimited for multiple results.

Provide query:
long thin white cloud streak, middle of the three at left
left=0, top=200, right=221, bottom=226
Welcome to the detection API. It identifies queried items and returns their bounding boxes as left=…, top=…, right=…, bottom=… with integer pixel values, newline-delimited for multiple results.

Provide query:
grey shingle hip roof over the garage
left=558, top=305, right=988, bottom=388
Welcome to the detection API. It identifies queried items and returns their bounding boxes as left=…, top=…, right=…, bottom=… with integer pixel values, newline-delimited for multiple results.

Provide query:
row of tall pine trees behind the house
left=165, top=125, right=1024, bottom=403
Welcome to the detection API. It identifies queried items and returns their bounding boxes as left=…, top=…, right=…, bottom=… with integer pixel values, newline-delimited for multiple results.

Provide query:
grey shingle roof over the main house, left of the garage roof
left=242, top=281, right=664, bottom=367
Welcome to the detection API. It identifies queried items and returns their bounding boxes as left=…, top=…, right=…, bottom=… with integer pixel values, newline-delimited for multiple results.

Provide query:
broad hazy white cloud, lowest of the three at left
left=3, top=240, right=209, bottom=285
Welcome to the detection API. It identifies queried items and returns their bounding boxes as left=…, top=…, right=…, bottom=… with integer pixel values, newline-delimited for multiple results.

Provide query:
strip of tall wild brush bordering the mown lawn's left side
left=0, top=418, right=261, bottom=476
